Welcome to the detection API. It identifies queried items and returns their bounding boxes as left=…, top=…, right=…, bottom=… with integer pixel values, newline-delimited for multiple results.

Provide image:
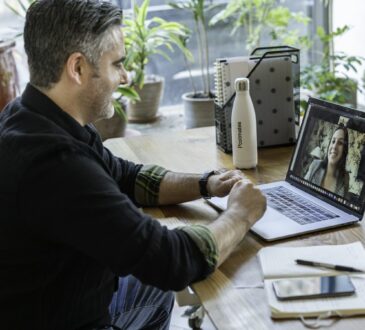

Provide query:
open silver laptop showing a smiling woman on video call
left=207, top=98, right=365, bottom=241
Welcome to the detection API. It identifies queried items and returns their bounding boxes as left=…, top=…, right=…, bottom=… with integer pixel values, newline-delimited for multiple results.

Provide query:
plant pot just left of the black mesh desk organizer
left=182, top=93, right=214, bottom=128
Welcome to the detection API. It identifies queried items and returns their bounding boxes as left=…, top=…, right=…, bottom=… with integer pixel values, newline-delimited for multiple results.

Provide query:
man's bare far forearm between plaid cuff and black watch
left=159, top=172, right=201, bottom=205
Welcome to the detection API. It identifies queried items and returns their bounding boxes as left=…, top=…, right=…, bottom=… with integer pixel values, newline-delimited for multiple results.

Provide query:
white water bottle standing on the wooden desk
left=231, top=78, right=257, bottom=169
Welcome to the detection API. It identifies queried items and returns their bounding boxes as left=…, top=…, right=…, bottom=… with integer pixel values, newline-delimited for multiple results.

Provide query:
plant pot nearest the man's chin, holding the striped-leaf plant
left=127, top=76, right=164, bottom=123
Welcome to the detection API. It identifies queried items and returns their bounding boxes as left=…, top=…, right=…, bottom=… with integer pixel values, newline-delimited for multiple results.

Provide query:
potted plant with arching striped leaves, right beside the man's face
left=123, top=0, right=191, bottom=122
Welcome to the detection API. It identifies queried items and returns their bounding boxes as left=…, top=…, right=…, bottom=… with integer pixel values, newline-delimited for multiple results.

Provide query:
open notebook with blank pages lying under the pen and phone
left=258, top=242, right=365, bottom=318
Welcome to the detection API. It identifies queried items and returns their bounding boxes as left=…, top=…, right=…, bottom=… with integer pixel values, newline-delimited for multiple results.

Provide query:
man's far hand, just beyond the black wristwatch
left=207, top=170, right=245, bottom=197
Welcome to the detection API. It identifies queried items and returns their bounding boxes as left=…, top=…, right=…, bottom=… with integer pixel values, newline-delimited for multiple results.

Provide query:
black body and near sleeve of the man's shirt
left=0, top=85, right=212, bottom=330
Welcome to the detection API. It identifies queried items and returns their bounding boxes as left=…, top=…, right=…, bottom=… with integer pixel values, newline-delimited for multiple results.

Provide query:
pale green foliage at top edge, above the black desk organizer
left=209, top=0, right=310, bottom=51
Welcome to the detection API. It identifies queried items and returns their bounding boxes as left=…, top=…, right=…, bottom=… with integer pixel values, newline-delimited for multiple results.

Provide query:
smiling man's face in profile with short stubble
left=82, top=28, right=127, bottom=122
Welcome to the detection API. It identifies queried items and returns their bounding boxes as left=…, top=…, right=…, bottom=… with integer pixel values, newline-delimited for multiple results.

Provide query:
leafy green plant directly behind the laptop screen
left=301, top=25, right=363, bottom=107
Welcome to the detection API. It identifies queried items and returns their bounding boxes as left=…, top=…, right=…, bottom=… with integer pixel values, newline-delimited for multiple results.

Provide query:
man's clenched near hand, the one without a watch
left=227, top=180, right=266, bottom=227
